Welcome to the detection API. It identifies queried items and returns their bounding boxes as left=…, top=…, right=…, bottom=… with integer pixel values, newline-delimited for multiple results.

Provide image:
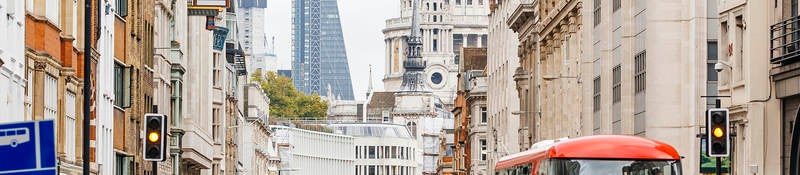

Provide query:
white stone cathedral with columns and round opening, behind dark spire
left=383, top=0, right=489, bottom=108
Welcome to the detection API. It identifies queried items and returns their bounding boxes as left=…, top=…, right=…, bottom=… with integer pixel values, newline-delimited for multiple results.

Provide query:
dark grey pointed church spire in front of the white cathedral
left=400, top=0, right=430, bottom=92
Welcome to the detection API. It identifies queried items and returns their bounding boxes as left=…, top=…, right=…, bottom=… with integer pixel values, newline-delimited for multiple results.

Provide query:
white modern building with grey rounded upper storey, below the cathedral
left=327, top=123, right=419, bottom=175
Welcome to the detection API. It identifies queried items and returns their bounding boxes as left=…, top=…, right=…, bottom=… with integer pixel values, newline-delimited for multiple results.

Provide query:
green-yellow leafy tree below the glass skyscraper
left=250, top=71, right=328, bottom=120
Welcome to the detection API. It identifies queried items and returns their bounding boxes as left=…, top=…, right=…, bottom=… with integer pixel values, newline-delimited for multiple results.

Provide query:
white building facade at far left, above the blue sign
left=0, top=1, right=26, bottom=123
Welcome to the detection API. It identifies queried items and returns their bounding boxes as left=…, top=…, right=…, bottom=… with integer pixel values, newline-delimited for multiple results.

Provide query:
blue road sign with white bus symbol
left=0, top=120, right=56, bottom=175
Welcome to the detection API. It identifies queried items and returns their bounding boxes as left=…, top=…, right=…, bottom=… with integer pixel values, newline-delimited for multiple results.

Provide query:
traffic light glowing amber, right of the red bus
left=706, top=108, right=731, bottom=157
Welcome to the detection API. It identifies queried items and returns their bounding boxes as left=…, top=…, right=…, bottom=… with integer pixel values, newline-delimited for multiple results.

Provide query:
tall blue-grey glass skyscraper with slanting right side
left=292, top=0, right=354, bottom=100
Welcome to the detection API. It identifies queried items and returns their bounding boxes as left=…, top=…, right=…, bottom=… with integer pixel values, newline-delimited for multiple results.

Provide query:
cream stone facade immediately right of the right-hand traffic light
left=736, top=0, right=784, bottom=174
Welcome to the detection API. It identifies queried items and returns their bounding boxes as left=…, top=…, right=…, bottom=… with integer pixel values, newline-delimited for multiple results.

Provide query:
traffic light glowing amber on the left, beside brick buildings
left=143, top=114, right=166, bottom=162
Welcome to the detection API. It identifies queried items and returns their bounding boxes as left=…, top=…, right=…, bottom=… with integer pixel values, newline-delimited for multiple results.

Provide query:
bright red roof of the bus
left=495, top=135, right=680, bottom=169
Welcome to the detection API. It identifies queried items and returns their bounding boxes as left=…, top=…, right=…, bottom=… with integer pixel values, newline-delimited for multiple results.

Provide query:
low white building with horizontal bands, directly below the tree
left=269, top=125, right=355, bottom=175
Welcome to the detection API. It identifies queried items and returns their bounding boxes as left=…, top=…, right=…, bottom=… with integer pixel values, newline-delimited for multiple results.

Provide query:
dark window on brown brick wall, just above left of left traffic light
left=114, top=63, right=131, bottom=108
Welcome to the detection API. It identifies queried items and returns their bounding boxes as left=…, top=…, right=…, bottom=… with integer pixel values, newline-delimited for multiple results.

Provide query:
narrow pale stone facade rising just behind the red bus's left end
left=485, top=0, right=530, bottom=174
